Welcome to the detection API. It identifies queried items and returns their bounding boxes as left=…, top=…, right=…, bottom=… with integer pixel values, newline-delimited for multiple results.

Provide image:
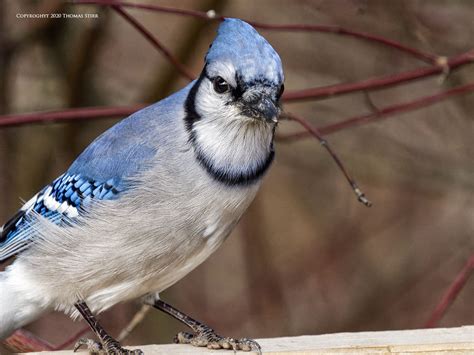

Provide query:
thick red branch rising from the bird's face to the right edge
left=282, top=49, right=474, bottom=102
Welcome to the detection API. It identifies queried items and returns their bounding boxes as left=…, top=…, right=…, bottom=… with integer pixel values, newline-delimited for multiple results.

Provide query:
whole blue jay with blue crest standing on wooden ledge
left=0, top=18, right=284, bottom=354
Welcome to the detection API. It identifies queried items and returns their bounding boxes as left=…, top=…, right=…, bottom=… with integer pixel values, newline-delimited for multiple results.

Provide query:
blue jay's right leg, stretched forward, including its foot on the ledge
left=145, top=299, right=262, bottom=354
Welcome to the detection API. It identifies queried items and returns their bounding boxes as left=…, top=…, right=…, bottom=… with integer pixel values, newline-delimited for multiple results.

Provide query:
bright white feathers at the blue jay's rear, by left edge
left=0, top=268, right=45, bottom=339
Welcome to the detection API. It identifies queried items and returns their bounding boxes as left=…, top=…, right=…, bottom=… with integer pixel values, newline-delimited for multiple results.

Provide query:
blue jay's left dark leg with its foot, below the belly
left=74, top=301, right=143, bottom=355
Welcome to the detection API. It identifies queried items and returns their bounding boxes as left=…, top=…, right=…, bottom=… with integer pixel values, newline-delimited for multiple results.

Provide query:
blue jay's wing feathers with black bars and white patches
left=0, top=173, right=121, bottom=261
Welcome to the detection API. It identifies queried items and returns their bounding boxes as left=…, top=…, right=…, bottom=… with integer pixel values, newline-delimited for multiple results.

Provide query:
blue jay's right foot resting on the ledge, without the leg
left=173, top=326, right=262, bottom=354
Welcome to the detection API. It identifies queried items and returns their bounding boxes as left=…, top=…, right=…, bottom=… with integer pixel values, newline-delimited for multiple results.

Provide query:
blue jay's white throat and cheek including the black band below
left=188, top=78, right=275, bottom=185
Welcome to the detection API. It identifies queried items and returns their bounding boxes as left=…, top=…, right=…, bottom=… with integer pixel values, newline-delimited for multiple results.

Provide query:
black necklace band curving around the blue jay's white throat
left=184, top=68, right=275, bottom=186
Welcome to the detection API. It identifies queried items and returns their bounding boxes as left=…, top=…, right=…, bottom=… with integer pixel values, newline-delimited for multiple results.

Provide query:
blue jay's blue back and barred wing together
left=0, top=87, right=193, bottom=261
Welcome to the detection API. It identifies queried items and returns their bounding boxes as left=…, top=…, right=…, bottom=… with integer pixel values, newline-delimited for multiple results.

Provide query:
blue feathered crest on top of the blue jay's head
left=206, top=18, right=284, bottom=86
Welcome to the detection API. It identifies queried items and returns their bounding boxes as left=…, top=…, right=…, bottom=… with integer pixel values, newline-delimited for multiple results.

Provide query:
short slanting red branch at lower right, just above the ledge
left=425, top=254, right=474, bottom=328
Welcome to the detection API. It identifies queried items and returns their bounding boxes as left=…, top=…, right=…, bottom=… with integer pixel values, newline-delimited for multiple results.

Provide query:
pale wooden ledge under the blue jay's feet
left=24, top=326, right=474, bottom=355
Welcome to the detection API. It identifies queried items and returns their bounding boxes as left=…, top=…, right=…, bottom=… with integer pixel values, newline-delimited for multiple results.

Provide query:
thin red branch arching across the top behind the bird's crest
left=76, top=0, right=439, bottom=64
